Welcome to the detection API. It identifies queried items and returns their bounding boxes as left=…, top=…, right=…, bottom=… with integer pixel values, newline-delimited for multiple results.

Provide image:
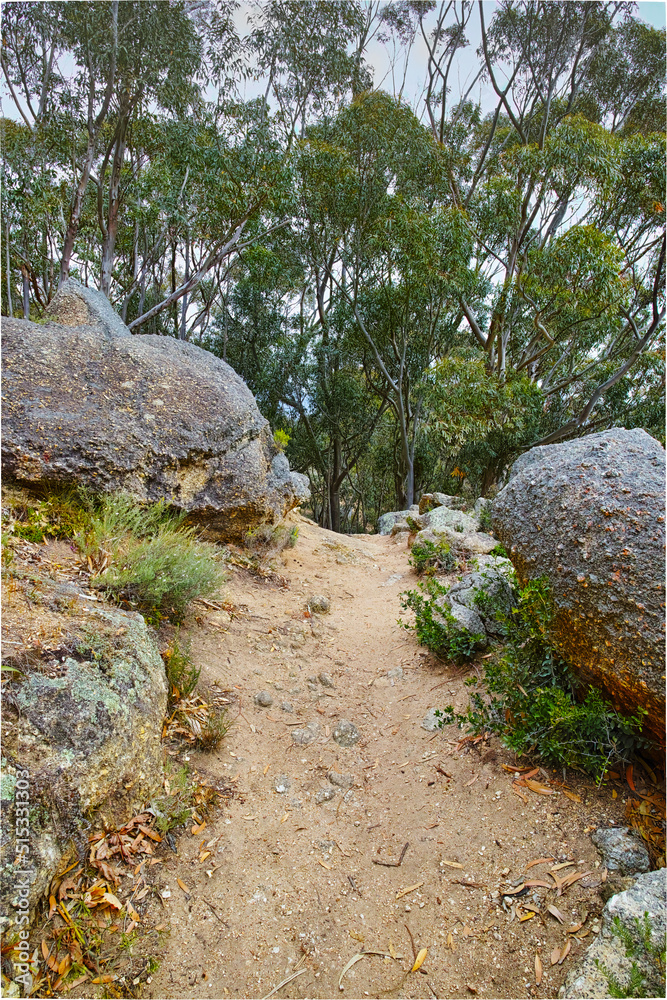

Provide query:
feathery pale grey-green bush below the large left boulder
left=77, top=494, right=222, bottom=621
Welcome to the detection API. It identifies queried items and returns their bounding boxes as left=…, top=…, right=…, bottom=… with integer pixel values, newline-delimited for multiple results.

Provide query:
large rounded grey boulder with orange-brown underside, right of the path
left=493, top=429, right=665, bottom=745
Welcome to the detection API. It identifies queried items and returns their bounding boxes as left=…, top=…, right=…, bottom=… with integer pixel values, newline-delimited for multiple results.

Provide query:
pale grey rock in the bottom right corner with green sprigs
left=560, top=868, right=666, bottom=1000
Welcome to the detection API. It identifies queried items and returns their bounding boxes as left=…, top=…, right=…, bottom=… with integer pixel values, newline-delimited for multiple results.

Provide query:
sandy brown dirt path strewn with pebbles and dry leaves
left=145, top=519, right=622, bottom=998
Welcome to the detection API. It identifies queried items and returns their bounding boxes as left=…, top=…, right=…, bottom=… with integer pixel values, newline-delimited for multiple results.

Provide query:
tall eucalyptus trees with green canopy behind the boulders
left=1, top=0, right=666, bottom=530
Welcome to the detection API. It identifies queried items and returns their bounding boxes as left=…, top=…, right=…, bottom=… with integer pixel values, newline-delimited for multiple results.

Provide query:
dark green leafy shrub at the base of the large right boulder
left=434, top=580, right=645, bottom=779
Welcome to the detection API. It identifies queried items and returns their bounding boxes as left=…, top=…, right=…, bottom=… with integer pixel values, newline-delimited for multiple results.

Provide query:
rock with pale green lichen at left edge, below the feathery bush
left=0, top=585, right=167, bottom=921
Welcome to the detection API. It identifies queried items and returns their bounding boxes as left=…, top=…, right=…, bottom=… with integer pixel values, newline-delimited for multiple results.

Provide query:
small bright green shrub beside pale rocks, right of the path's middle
left=399, top=579, right=484, bottom=663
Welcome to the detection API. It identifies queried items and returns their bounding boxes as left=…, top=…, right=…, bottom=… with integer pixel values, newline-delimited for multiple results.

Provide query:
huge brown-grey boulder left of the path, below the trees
left=2, top=282, right=304, bottom=540
